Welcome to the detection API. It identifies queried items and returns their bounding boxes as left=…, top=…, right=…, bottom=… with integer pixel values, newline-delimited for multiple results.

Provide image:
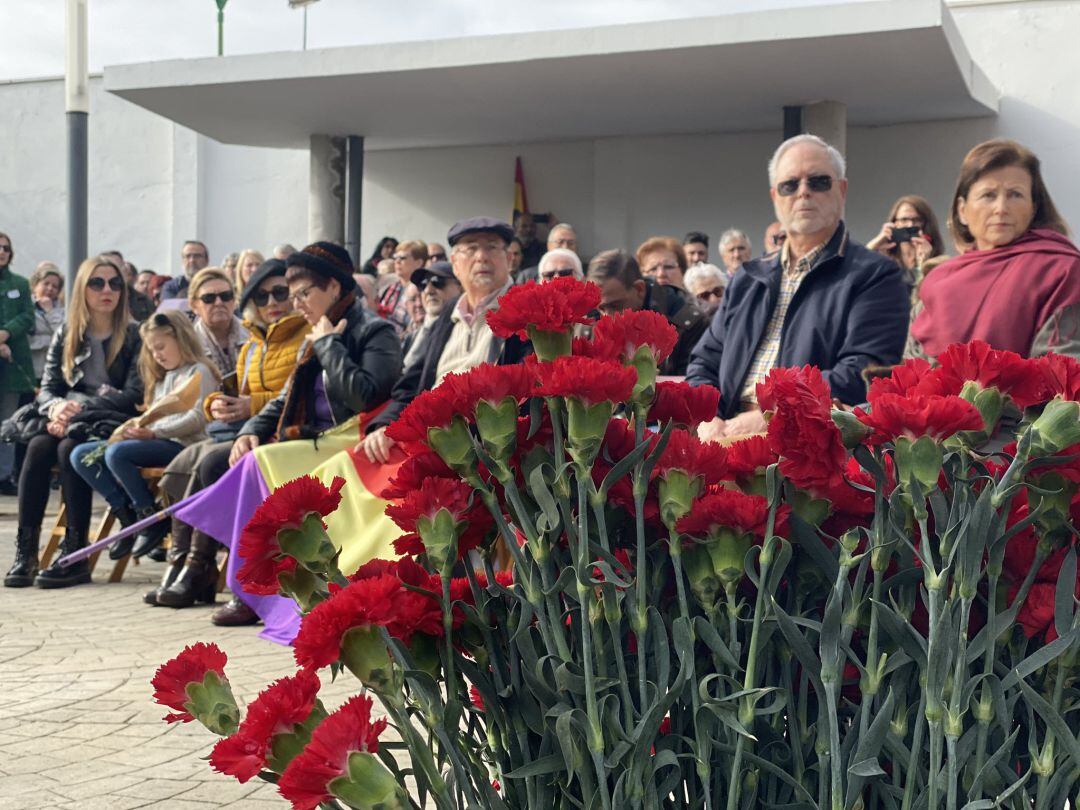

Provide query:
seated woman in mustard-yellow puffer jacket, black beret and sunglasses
left=146, top=259, right=311, bottom=608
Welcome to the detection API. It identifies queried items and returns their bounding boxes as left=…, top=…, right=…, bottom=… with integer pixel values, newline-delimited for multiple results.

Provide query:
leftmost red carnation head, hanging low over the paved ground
left=150, top=642, right=240, bottom=734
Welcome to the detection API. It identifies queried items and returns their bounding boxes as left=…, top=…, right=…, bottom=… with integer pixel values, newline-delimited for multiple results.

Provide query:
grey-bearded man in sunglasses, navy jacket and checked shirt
left=687, top=135, right=908, bottom=440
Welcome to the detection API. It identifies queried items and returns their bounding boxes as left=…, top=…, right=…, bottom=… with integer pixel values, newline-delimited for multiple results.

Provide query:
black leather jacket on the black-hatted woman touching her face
left=240, top=300, right=402, bottom=441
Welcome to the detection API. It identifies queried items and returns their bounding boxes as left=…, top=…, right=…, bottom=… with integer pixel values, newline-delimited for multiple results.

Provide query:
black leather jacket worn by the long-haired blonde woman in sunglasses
left=37, top=323, right=143, bottom=416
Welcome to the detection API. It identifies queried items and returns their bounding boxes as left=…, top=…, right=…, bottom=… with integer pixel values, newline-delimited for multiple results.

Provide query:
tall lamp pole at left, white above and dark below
left=64, top=0, right=90, bottom=289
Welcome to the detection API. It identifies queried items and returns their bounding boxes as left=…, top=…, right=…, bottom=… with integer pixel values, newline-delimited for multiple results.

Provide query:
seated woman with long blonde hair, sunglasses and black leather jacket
left=4, top=256, right=143, bottom=588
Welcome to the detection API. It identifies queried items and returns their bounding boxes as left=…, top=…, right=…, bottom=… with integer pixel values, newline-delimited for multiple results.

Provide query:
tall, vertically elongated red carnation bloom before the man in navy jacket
left=757, top=366, right=848, bottom=494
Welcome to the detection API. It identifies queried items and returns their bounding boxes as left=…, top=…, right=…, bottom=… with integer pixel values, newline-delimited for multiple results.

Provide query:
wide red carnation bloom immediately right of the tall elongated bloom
left=855, top=394, right=984, bottom=443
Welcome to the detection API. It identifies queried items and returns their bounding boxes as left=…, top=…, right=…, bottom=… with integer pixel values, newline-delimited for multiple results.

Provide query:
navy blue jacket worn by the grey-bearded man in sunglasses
left=686, top=222, right=908, bottom=419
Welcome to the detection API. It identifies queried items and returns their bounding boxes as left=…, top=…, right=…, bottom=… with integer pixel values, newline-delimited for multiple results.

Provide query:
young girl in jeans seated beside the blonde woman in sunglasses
left=71, top=310, right=220, bottom=556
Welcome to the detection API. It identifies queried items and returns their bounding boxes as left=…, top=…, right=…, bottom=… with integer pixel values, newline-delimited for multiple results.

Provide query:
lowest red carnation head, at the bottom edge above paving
left=278, top=694, right=408, bottom=810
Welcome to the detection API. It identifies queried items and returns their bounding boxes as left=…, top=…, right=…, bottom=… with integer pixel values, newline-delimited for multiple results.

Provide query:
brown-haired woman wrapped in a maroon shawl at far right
left=908, top=139, right=1080, bottom=359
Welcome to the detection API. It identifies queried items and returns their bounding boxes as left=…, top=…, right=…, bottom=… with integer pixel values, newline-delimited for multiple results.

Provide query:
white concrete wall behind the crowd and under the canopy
left=0, top=0, right=1080, bottom=272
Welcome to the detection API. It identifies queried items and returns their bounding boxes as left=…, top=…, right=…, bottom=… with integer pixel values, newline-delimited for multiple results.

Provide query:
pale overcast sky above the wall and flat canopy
left=0, top=0, right=850, bottom=80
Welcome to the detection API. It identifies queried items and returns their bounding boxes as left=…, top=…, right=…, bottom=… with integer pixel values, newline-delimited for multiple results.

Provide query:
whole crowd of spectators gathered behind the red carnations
left=0, top=135, right=1080, bottom=629
